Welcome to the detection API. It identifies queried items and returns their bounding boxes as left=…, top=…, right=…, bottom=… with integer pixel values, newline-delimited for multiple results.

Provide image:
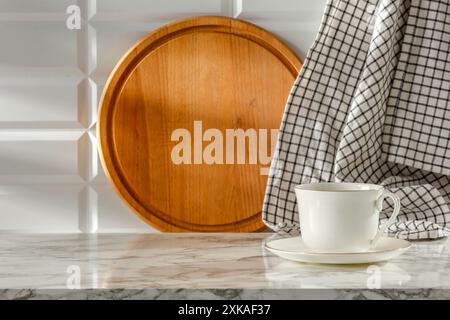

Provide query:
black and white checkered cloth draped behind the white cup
left=263, top=0, right=450, bottom=239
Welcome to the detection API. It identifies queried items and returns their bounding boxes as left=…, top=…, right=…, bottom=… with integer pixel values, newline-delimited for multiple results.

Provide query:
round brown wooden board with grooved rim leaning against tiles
left=98, top=17, right=301, bottom=232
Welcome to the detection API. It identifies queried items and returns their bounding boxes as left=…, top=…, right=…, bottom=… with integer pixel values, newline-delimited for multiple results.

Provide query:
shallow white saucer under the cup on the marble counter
left=265, top=237, right=411, bottom=264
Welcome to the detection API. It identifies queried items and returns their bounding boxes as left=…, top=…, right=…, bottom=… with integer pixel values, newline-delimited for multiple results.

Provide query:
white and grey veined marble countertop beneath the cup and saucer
left=0, top=233, right=450, bottom=298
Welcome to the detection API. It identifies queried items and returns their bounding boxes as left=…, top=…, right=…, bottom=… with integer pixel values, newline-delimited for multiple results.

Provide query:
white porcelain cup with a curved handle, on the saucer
left=295, top=183, right=400, bottom=253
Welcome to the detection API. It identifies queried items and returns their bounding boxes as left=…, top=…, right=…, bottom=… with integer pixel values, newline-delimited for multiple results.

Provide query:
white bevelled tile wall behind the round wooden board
left=0, top=0, right=326, bottom=232
